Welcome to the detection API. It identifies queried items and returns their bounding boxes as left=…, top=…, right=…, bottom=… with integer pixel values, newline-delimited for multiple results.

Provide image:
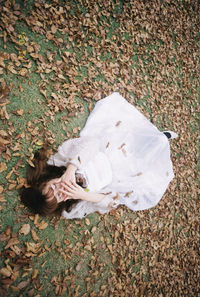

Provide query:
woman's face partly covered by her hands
left=42, top=178, right=67, bottom=203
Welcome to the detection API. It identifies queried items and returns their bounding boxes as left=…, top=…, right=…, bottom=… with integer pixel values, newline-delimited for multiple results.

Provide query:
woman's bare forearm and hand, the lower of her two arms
left=57, top=182, right=105, bottom=203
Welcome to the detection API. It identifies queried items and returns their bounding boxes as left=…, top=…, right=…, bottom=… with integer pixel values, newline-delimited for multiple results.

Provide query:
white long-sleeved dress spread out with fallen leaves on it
left=48, top=93, right=177, bottom=219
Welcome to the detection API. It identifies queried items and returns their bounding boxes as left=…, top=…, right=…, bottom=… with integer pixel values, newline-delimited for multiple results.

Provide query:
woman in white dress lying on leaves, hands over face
left=21, top=93, right=177, bottom=219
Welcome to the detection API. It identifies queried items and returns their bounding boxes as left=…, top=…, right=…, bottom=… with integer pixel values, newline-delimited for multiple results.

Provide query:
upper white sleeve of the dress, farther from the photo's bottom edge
left=48, top=136, right=99, bottom=170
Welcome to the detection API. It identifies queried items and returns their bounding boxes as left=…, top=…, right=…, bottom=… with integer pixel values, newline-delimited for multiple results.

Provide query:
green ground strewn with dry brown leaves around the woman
left=0, top=0, right=200, bottom=297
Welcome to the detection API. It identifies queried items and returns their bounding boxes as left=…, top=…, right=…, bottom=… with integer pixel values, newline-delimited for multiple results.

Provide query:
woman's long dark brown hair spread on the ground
left=20, top=147, right=79, bottom=215
